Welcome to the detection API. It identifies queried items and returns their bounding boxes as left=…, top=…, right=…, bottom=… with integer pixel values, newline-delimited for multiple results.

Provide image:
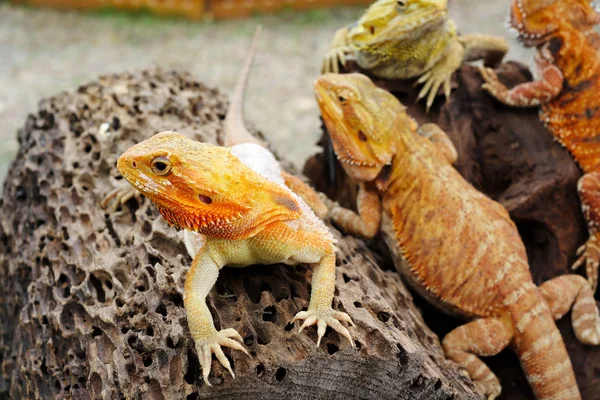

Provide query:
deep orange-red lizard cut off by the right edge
left=481, top=0, right=600, bottom=290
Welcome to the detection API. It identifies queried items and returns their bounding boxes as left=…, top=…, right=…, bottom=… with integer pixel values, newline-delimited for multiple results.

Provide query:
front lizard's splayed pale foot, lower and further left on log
left=194, top=328, right=250, bottom=386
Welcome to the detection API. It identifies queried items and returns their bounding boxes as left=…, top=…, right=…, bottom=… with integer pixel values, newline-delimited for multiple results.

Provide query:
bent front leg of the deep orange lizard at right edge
left=480, top=45, right=563, bottom=107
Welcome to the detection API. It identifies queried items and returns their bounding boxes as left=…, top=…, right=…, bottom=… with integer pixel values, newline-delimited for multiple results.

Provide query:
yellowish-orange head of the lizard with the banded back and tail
left=314, top=73, right=414, bottom=181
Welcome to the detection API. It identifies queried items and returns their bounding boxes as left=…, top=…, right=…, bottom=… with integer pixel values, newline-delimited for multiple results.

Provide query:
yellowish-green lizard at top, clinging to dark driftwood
left=322, top=0, right=508, bottom=110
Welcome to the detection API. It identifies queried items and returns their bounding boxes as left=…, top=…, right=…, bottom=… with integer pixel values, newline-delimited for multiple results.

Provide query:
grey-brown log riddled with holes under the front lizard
left=0, top=70, right=481, bottom=399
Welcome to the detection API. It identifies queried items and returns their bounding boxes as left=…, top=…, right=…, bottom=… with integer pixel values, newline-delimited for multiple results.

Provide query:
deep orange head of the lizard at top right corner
left=507, top=0, right=600, bottom=47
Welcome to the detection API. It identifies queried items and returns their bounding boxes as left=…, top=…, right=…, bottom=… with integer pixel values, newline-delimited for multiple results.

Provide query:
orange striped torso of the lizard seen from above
left=383, top=148, right=531, bottom=317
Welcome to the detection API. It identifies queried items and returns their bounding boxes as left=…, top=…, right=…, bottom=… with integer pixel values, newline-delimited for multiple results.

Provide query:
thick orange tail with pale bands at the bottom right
left=513, top=293, right=581, bottom=400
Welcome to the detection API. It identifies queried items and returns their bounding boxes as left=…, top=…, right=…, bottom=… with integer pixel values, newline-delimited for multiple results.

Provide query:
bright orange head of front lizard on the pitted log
left=117, top=132, right=300, bottom=238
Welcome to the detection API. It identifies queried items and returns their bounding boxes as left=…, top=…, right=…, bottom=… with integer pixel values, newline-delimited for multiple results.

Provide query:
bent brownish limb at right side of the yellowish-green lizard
left=458, top=33, right=508, bottom=67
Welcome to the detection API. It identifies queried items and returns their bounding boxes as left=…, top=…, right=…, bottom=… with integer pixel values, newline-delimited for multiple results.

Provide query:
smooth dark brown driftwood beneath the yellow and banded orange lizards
left=304, top=62, right=600, bottom=400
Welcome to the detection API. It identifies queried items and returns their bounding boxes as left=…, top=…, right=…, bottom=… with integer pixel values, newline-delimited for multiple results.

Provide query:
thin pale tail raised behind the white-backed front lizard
left=223, top=25, right=263, bottom=147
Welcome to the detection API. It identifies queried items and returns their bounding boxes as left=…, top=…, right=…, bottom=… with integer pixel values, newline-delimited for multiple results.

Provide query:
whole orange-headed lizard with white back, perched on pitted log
left=106, top=27, right=354, bottom=385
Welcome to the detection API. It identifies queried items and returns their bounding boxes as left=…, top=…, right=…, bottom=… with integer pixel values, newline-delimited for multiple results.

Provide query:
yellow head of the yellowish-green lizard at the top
left=351, top=0, right=448, bottom=44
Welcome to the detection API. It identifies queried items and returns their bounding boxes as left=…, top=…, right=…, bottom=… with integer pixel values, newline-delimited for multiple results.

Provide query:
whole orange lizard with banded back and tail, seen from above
left=315, top=74, right=600, bottom=400
